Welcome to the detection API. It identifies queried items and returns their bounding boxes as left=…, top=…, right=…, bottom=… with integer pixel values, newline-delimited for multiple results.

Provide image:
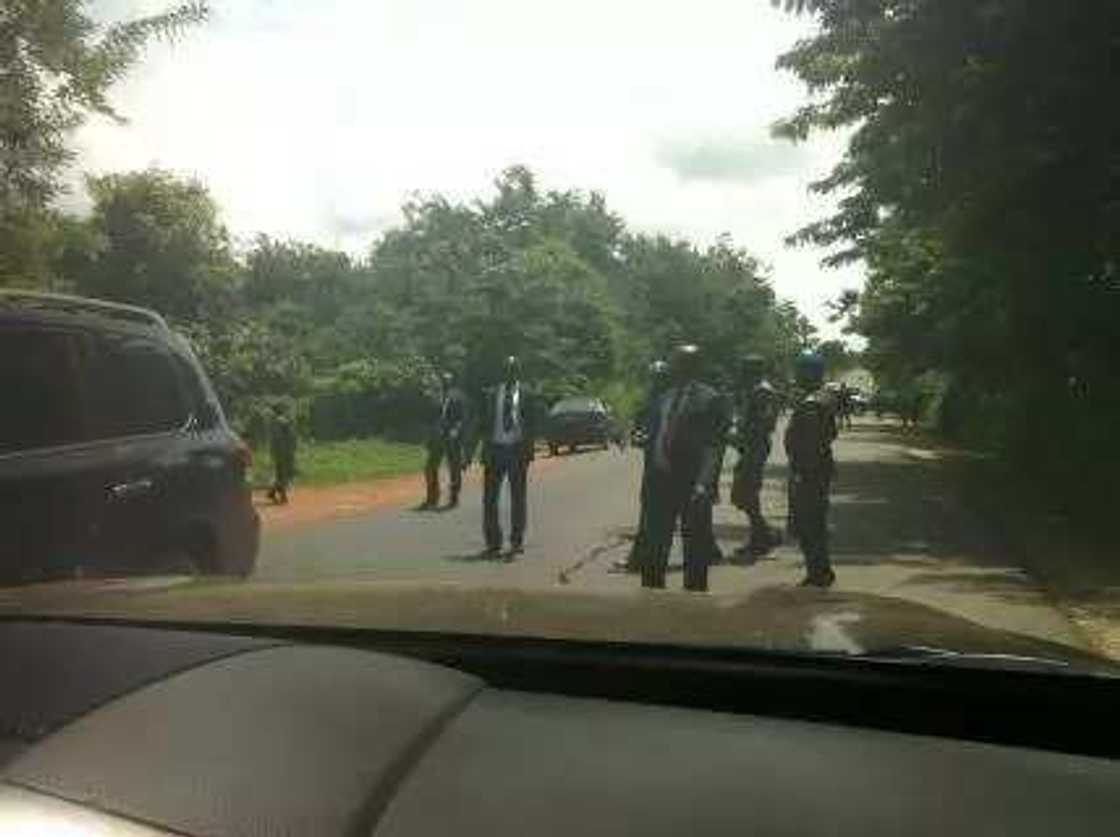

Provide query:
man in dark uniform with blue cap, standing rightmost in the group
left=785, top=352, right=837, bottom=587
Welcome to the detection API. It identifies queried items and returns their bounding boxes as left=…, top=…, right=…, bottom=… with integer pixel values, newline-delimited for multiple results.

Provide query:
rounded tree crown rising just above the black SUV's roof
left=69, top=169, right=236, bottom=320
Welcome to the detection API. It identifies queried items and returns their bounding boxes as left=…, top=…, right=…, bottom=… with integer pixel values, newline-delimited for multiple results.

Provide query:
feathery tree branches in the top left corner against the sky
left=0, top=0, right=207, bottom=285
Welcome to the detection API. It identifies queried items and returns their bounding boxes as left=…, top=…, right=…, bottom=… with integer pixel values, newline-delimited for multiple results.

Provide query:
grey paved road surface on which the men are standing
left=258, top=421, right=1083, bottom=650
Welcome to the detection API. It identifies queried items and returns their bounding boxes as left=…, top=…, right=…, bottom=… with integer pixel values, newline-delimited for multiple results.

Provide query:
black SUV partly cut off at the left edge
left=0, top=290, right=260, bottom=584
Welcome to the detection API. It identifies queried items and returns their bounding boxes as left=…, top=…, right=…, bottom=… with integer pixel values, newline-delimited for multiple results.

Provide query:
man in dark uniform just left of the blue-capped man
left=731, top=354, right=780, bottom=557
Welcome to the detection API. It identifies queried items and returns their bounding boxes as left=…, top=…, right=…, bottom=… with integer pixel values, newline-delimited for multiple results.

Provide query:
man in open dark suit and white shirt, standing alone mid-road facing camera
left=470, top=355, right=539, bottom=557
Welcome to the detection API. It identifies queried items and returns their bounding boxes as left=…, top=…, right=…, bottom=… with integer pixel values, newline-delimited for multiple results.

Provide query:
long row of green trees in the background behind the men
left=43, top=167, right=812, bottom=444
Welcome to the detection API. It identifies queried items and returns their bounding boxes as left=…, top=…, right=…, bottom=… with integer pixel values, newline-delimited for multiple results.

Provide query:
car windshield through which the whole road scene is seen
left=0, top=0, right=1120, bottom=672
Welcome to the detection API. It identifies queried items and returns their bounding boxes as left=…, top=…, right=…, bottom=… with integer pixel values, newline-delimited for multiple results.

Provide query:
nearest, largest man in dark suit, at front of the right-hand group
left=641, top=345, right=727, bottom=592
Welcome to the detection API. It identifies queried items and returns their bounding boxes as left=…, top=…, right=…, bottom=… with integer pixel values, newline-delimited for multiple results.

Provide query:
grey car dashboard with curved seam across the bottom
left=0, top=621, right=1120, bottom=837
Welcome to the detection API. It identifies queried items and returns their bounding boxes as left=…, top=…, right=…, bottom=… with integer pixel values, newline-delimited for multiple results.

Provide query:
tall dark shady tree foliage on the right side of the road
left=777, top=0, right=1120, bottom=531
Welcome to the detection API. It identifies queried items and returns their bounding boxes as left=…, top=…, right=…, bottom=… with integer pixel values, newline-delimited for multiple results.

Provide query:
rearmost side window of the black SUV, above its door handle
left=91, top=337, right=189, bottom=439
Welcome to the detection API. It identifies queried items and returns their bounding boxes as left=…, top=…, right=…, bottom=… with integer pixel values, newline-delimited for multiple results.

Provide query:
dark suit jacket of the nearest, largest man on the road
left=647, top=381, right=729, bottom=485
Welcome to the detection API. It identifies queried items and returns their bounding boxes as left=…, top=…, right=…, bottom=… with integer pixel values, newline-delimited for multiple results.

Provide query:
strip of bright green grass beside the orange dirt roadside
left=250, top=438, right=424, bottom=489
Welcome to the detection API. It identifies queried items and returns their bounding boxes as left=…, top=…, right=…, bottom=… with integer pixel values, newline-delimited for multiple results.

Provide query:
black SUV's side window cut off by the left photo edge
left=0, top=327, right=88, bottom=454
